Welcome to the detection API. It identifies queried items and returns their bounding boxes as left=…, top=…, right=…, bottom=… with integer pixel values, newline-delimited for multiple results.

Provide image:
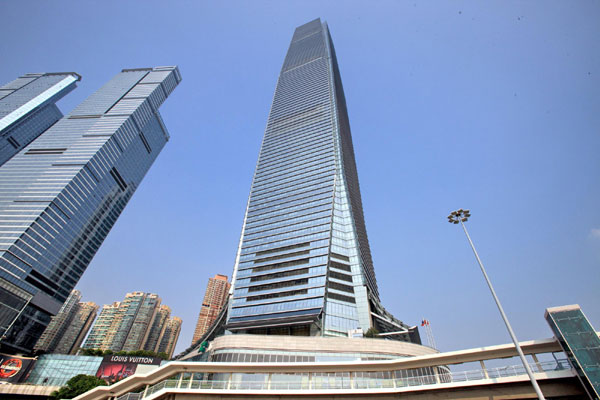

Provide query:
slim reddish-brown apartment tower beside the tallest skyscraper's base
left=192, top=274, right=231, bottom=344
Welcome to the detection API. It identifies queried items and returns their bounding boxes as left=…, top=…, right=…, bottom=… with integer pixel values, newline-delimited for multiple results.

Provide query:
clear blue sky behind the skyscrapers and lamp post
left=0, top=0, right=600, bottom=351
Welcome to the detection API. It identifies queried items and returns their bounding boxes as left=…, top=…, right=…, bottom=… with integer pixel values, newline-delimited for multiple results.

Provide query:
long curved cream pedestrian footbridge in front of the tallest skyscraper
left=76, top=339, right=585, bottom=400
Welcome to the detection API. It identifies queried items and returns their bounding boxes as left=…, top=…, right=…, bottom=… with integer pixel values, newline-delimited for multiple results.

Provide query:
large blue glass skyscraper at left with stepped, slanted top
left=0, top=67, right=181, bottom=352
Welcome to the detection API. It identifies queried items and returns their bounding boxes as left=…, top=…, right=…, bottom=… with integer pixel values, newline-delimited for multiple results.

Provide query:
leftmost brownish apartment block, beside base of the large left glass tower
left=34, top=290, right=98, bottom=354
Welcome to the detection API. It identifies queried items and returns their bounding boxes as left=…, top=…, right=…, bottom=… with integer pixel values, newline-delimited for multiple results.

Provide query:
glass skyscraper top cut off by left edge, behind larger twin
left=0, top=72, right=81, bottom=165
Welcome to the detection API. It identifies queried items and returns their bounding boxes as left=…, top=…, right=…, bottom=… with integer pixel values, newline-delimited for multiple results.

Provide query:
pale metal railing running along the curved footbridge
left=134, top=360, right=571, bottom=400
